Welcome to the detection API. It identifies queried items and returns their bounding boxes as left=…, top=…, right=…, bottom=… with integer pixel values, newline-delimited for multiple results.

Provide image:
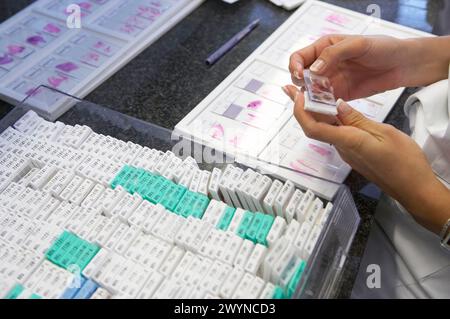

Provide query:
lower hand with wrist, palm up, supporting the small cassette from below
left=284, top=85, right=450, bottom=233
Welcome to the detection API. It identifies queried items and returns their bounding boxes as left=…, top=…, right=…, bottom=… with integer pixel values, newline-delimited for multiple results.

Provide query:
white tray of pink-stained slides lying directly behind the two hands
left=174, top=1, right=431, bottom=199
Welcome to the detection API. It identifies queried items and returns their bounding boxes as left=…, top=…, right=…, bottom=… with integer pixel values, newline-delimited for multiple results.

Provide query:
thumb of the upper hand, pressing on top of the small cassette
left=310, top=36, right=370, bottom=74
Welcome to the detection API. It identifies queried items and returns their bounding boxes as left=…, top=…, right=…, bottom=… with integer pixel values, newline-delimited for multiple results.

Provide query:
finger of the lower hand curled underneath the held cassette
left=283, top=85, right=359, bottom=145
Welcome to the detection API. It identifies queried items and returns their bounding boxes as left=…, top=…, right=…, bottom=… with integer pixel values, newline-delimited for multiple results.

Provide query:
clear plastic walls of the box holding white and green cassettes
left=0, top=86, right=360, bottom=298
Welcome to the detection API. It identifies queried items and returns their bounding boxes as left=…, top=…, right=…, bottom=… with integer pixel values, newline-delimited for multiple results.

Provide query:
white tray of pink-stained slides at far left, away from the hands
left=0, top=0, right=203, bottom=120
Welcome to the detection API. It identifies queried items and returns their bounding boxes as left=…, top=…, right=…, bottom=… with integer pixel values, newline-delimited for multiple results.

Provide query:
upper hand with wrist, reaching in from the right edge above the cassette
left=289, top=35, right=450, bottom=100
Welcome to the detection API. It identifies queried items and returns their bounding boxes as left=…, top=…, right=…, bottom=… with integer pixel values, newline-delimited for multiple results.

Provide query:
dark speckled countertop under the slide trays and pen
left=0, top=0, right=448, bottom=298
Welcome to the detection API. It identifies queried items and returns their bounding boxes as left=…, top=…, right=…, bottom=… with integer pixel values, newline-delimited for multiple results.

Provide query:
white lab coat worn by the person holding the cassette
left=352, top=67, right=450, bottom=298
